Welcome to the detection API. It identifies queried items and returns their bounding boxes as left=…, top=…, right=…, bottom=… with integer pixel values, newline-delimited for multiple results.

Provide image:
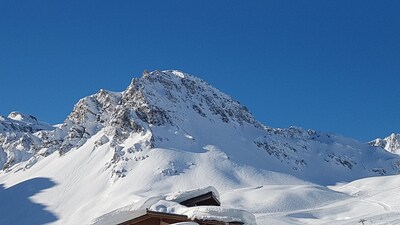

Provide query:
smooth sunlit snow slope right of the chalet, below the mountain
left=221, top=175, right=400, bottom=225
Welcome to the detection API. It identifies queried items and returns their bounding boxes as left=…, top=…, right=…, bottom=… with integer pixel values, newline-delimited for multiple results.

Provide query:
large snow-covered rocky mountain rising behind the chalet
left=0, top=70, right=400, bottom=224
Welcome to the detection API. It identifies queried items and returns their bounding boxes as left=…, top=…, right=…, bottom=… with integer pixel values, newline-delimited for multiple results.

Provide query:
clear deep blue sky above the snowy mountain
left=0, top=0, right=400, bottom=141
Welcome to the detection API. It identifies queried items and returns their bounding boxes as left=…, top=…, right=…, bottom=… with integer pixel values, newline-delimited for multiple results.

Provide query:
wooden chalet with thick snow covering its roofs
left=93, top=187, right=254, bottom=225
